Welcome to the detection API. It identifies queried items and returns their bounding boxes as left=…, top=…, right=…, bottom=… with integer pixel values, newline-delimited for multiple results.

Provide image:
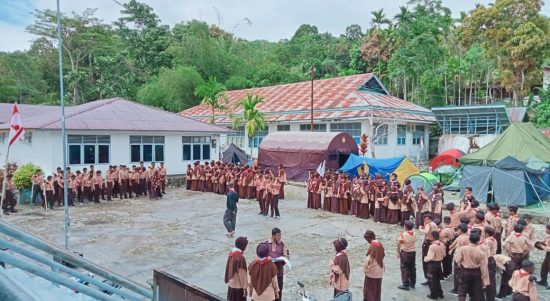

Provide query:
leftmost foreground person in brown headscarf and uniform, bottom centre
left=225, top=237, right=248, bottom=301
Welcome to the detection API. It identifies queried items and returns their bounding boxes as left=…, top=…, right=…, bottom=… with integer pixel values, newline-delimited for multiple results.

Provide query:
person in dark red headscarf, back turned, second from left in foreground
left=248, top=243, right=279, bottom=301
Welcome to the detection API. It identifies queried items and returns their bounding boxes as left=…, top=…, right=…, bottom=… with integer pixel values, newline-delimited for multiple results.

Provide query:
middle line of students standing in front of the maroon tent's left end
left=186, top=161, right=287, bottom=218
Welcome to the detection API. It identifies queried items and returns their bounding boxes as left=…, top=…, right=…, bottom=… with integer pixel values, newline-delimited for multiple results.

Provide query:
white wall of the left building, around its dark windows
left=0, top=130, right=220, bottom=175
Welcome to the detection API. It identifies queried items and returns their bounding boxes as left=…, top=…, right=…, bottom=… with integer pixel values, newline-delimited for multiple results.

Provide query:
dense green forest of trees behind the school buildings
left=0, top=0, right=550, bottom=127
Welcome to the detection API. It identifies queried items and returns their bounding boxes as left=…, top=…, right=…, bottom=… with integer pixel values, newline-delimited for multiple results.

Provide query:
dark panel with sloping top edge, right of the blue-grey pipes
left=153, top=270, right=225, bottom=301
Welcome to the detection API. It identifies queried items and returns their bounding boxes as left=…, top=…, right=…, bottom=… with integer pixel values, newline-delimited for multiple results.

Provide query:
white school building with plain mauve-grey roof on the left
left=0, top=98, right=228, bottom=175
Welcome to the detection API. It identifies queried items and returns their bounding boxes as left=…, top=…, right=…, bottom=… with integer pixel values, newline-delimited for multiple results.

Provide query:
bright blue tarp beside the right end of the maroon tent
left=340, top=154, right=405, bottom=180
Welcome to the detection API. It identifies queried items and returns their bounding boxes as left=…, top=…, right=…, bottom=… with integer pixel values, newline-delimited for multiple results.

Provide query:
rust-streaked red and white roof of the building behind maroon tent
left=180, top=73, right=435, bottom=124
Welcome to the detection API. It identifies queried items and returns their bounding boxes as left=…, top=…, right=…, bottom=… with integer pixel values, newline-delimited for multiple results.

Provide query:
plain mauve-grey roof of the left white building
left=0, top=98, right=228, bottom=133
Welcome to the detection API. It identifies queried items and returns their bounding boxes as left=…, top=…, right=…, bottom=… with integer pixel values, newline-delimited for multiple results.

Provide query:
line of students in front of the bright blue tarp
left=307, top=171, right=444, bottom=227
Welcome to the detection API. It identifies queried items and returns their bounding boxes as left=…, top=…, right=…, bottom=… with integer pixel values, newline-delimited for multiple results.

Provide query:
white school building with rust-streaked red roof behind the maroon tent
left=180, top=73, right=436, bottom=161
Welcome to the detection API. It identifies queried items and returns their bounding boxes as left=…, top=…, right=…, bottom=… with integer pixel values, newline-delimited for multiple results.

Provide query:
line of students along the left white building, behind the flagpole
left=27, top=162, right=167, bottom=208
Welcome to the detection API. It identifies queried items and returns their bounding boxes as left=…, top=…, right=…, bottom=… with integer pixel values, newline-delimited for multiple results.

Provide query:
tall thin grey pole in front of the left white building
left=57, top=0, right=69, bottom=249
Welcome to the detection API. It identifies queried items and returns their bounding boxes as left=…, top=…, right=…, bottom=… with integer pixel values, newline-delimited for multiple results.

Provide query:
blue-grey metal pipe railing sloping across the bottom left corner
left=0, top=221, right=153, bottom=301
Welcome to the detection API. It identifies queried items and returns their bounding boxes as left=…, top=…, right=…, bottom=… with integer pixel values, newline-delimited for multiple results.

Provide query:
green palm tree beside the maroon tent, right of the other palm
left=233, top=93, right=267, bottom=157
